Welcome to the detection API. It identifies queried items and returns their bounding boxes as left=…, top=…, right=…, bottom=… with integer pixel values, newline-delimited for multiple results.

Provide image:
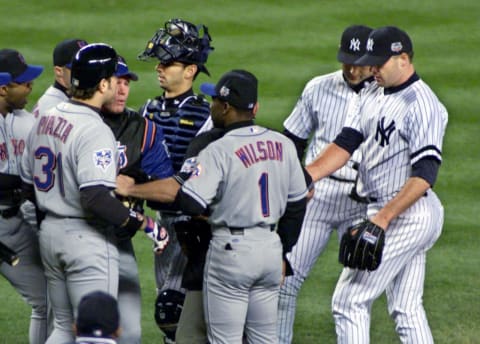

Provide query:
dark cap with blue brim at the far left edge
left=0, top=49, right=43, bottom=84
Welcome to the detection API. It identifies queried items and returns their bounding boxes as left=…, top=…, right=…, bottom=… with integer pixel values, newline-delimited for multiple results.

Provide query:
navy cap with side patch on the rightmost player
left=355, top=26, right=413, bottom=66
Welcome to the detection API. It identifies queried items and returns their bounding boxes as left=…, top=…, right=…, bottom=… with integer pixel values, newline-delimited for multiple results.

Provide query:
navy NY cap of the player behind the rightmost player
left=337, top=25, right=373, bottom=65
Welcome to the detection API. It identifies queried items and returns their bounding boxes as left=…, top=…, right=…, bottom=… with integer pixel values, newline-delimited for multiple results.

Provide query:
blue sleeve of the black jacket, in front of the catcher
left=141, top=120, right=174, bottom=178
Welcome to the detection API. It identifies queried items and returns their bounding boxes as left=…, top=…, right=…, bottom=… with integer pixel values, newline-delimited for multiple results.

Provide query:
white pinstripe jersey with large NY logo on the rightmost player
left=345, top=80, right=448, bottom=199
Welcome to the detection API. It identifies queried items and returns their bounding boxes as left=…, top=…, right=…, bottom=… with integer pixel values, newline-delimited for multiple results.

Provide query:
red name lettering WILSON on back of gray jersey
left=235, top=140, right=283, bottom=168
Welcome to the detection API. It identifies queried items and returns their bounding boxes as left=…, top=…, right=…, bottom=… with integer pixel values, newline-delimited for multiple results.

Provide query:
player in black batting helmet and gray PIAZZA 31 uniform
left=21, top=43, right=167, bottom=344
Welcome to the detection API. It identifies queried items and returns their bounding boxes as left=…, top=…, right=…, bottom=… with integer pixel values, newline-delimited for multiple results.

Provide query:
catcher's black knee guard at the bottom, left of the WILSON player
left=155, top=289, right=185, bottom=341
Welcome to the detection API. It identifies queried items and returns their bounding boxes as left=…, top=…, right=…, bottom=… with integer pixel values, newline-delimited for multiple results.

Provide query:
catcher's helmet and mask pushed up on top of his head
left=138, top=19, right=213, bottom=75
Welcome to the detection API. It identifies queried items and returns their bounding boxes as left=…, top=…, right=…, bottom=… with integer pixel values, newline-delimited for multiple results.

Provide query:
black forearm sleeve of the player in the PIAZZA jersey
left=80, top=186, right=130, bottom=226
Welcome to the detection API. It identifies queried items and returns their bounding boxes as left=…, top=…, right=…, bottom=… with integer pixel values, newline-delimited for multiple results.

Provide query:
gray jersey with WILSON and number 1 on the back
left=183, top=125, right=307, bottom=227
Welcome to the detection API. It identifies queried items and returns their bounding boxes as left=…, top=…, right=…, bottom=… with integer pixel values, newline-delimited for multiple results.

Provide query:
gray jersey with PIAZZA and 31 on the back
left=22, top=102, right=117, bottom=217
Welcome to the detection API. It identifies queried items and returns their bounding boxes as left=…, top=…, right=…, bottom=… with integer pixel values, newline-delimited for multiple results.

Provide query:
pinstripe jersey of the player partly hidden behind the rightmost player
left=283, top=70, right=366, bottom=181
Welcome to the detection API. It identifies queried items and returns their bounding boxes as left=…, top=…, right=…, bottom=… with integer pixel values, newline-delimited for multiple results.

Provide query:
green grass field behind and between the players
left=0, top=0, right=480, bottom=344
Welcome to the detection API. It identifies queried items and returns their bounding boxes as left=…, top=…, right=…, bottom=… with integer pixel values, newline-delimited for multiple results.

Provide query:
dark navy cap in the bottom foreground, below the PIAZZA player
left=75, top=291, right=120, bottom=338
